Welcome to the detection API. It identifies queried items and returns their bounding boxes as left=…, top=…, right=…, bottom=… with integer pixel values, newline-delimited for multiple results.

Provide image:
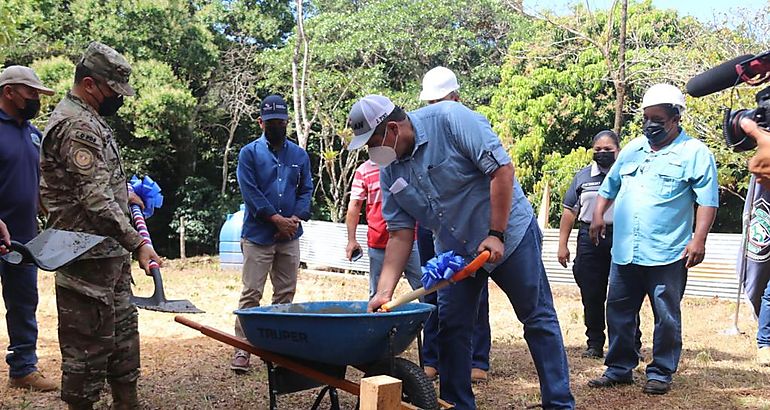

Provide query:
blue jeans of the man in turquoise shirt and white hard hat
left=604, top=260, right=687, bottom=383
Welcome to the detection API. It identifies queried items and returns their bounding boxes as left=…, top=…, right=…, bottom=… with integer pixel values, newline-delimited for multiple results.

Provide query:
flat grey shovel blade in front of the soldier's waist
left=0, top=229, right=106, bottom=271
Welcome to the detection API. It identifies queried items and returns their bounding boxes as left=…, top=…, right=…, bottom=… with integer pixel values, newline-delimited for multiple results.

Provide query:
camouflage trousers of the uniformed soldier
left=56, top=255, right=139, bottom=405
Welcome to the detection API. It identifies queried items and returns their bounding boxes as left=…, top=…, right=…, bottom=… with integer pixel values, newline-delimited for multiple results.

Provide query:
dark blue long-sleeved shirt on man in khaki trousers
left=237, top=134, right=313, bottom=245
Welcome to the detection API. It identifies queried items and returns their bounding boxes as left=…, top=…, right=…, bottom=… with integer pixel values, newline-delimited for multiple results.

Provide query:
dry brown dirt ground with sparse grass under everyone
left=0, top=258, right=770, bottom=409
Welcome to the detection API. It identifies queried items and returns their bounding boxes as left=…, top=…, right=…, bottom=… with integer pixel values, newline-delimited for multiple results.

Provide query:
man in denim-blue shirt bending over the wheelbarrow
left=348, top=95, right=574, bottom=409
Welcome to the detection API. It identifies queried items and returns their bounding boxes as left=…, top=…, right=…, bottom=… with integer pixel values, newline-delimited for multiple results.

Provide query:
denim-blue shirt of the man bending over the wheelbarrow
left=380, top=101, right=533, bottom=270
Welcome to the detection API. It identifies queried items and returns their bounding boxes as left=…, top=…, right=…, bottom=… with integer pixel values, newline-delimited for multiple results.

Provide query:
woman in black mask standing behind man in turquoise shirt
left=558, top=130, right=641, bottom=358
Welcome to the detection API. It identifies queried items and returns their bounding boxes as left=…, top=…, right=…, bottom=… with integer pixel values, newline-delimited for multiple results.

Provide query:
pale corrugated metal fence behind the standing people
left=300, top=221, right=740, bottom=299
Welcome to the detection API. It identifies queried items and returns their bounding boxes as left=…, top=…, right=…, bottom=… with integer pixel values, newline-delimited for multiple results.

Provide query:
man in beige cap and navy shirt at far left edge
left=0, top=66, right=58, bottom=391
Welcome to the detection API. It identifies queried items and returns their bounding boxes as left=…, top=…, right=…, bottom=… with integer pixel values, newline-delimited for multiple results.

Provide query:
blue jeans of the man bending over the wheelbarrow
left=438, top=218, right=575, bottom=410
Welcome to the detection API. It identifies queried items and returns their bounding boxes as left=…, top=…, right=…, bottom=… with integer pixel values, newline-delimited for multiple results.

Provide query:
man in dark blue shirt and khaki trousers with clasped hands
left=230, top=95, right=313, bottom=372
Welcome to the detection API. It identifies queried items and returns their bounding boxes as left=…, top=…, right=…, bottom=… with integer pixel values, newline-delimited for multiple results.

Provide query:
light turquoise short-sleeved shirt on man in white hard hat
left=599, top=131, right=719, bottom=266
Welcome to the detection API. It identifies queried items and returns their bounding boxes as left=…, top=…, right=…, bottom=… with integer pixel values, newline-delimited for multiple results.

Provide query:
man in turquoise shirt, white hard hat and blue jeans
left=588, top=84, right=719, bottom=394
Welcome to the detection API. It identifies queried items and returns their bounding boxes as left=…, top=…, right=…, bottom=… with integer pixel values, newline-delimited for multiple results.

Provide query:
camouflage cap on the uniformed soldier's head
left=80, top=41, right=135, bottom=97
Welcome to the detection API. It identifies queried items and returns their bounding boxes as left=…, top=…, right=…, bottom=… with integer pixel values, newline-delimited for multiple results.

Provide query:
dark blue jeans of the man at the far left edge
left=0, top=261, right=37, bottom=378
